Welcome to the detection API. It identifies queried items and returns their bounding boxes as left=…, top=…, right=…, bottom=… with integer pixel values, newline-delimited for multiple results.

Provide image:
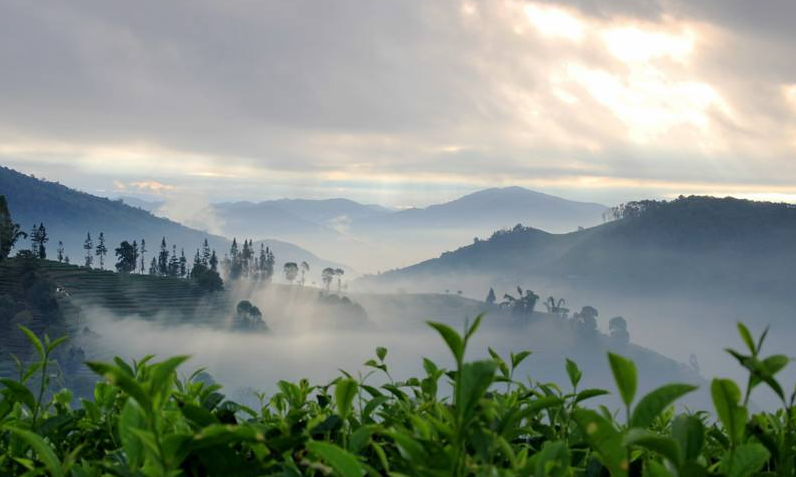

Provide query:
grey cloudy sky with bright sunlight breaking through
left=0, top=0, right=796, bottom=206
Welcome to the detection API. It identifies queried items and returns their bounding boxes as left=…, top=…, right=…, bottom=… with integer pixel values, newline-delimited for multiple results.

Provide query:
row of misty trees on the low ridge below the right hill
left=485, top=286, right=630, bottom=344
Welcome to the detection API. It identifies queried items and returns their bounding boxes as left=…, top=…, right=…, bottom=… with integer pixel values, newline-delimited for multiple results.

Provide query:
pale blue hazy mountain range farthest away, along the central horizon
left=123, top=187, right=607, bottom=271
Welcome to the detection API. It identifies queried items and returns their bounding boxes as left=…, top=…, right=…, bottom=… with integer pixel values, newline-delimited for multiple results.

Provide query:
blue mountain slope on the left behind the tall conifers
left=0, top=167, right=347, bottom=270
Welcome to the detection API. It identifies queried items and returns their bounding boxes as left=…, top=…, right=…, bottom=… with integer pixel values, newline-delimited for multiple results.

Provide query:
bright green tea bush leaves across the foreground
left=0, top=317, right=796, bottom=477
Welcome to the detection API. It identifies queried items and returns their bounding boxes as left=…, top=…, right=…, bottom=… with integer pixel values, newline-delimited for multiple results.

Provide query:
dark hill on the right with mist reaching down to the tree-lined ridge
left=352, top=193, right=796, bottom=394
